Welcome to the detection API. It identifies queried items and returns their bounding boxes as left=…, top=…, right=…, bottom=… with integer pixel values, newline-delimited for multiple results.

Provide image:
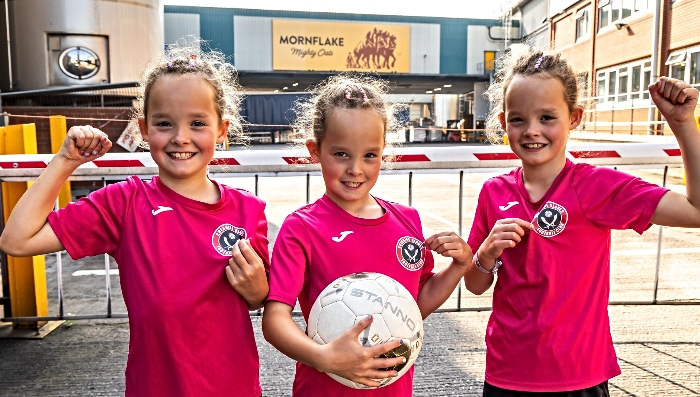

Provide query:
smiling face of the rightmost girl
left=499, top=76, right=582, bottom=169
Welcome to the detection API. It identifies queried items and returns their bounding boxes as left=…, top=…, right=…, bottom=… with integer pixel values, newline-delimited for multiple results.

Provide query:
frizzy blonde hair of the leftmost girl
left=131, top=39, right=242, bottom=147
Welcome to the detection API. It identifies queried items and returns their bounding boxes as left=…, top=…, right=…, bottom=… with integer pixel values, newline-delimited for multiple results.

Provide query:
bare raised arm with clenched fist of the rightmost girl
left=649, top=77, right=700, bottom=227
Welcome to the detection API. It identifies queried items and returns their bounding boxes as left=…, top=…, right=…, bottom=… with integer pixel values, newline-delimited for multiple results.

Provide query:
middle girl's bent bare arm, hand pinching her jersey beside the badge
left=418, top=232, right=472, bottom=318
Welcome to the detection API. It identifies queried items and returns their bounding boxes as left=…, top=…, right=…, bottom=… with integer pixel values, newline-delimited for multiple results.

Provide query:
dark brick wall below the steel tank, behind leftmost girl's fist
left=2, top=106, right=131, bottom=154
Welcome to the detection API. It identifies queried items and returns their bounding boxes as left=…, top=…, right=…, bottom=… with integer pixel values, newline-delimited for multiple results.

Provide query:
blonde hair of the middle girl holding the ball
left=293, top=73, right=406, bottom=145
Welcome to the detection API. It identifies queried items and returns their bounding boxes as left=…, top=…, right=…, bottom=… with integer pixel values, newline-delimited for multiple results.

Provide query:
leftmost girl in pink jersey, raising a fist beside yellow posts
left=0, top=48, right=269, bottom=397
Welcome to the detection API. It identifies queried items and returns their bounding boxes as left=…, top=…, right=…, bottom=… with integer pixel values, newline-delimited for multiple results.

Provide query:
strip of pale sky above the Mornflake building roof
left=163, top=0, right=513, bottom=19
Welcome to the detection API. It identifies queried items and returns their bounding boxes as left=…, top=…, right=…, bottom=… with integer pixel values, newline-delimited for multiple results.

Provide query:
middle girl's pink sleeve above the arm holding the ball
left=267, top=214, right=311, bottom=307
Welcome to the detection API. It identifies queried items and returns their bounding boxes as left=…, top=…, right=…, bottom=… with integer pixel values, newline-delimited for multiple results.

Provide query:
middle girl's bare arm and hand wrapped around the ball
left=262, top=300, right=405, bottom=387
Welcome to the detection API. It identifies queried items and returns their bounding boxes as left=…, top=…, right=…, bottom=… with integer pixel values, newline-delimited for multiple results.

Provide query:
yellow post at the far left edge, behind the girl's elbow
left=0, top=124, right=49, bottom=330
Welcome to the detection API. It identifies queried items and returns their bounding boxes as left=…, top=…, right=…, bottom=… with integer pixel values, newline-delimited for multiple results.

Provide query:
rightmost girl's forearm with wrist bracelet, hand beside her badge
left=464, top=218, right=532, bottom=295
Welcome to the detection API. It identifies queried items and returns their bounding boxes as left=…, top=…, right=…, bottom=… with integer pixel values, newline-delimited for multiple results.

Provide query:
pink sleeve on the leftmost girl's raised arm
left=49, top=178, right=134, bottom=260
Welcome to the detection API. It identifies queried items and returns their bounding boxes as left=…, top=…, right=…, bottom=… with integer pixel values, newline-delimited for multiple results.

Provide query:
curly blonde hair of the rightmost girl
left=484, top=45, right=580, bottom=144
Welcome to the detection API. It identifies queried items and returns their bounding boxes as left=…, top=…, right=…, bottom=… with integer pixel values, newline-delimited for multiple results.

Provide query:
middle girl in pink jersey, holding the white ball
left=263, top=75, right=472, bottom=397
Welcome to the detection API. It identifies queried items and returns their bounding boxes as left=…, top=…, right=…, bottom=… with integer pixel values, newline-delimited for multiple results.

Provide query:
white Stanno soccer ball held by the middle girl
left=306, top=273, right=423, bottom=389
